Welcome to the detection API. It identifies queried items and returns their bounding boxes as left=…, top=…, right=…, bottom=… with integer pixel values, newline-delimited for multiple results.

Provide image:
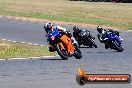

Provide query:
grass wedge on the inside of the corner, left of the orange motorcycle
left=0, top=40, right=57, bottom=59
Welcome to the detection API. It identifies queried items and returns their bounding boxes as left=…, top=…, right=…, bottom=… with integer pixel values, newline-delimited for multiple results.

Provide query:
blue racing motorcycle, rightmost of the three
left=100, top=32, right=124, bottom=52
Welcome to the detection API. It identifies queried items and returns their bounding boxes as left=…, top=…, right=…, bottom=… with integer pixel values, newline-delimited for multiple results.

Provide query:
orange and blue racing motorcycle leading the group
left=48, top=28, right=82, bottom=60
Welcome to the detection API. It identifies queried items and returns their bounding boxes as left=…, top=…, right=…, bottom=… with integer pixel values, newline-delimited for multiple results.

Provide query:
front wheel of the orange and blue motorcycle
left=55, top=43, right=68, bottom=60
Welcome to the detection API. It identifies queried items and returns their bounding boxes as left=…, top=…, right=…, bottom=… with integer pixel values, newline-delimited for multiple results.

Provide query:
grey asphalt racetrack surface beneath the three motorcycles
left=0, top=17, right=132, bottom=88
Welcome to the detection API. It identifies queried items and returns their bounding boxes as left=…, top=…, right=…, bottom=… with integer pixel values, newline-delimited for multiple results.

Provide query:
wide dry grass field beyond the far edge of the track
left=0, top=0, right=132, bottom=29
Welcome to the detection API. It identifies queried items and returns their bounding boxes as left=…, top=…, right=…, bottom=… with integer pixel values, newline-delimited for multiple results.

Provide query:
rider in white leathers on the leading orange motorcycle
left=44, top=23, right=77, bottom=54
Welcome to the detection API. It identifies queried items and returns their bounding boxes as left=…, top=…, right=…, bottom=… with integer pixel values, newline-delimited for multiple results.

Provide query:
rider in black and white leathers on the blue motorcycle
left=97, top=26, right=123, bottom=47
